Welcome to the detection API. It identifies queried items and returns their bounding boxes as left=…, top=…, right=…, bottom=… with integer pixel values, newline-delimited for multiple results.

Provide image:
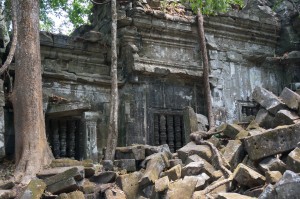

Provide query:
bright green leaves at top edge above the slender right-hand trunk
left=183, top=0, right=244, bottom=15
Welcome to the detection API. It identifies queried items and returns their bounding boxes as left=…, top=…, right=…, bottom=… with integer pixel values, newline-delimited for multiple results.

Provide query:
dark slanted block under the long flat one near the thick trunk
left=46, top=178, right=79, bottom=194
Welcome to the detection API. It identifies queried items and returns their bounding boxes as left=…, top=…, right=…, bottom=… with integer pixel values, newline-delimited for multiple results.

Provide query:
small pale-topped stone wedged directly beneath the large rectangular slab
left=258, top=157, right=286, bottom=173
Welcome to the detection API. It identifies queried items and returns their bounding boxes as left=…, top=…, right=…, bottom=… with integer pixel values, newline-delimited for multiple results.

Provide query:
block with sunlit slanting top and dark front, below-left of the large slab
left=233, top=163, right=266, bottom=187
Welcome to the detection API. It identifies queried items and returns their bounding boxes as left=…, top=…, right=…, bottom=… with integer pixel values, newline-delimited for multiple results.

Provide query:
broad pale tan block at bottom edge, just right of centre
left=167, top=178, right=197, bottom=199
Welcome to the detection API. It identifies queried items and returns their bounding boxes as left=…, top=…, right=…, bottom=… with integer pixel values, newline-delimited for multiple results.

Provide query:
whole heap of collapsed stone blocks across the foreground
left=0, top=87, right=300, bottom=199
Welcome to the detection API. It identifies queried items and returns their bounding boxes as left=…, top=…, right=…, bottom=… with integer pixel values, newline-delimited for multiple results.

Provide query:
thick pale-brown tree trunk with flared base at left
left=12, top=0, right=53, bottom=182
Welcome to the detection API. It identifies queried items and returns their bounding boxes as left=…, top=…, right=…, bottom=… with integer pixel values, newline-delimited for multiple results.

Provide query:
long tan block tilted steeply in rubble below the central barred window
left=139, top=153, right=169, bottom=188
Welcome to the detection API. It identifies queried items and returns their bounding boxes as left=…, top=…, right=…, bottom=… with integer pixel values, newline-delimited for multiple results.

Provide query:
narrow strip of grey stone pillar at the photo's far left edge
left=0, top=79, right=5, bottom=159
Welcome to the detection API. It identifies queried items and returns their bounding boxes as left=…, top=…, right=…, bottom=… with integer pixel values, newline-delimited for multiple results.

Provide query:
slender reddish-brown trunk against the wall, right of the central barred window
left=197, top=9, right=215, bottom=128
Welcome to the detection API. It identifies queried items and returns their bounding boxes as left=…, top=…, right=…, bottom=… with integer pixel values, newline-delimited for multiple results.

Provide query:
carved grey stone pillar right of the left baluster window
left=82, top=112, right=99, bottom=162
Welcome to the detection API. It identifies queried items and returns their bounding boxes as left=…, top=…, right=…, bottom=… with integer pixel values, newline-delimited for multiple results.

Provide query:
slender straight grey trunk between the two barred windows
left=105, top=0, right=119, bottom=160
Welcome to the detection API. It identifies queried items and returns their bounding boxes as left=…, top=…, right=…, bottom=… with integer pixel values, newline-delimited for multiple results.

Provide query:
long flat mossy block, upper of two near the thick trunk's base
left=44, top=166, right=84, bottom=186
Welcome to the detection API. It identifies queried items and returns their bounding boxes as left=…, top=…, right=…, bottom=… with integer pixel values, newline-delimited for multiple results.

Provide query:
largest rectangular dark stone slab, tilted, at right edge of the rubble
left=244, top=124, right=300, bottom=160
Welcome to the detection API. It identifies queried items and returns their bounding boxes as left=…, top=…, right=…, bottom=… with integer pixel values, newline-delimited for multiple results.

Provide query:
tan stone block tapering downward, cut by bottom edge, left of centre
left=116, top=172, right=143, bottom=199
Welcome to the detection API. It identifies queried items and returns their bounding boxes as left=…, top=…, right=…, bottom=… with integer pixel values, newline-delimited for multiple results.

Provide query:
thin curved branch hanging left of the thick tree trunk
left=0, top=0, right=18, bottom=75
